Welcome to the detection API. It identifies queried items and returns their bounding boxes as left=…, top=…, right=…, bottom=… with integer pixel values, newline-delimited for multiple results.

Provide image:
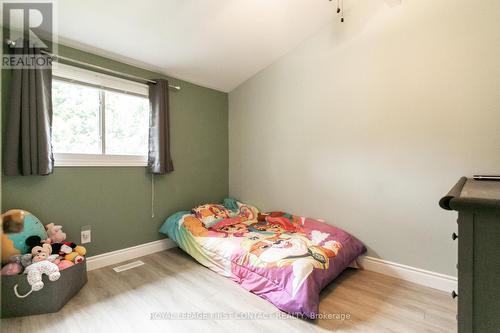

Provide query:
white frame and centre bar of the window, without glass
left=53, top=63, right=148, bottom=167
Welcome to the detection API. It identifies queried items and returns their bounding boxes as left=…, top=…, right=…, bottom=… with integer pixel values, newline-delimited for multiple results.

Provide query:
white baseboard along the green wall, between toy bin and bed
left=87, top=238, right=177, bottom=271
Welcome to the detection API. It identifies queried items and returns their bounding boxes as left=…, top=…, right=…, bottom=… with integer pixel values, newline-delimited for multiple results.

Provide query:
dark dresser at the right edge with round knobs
left=439, top=177, right=500, bottom=333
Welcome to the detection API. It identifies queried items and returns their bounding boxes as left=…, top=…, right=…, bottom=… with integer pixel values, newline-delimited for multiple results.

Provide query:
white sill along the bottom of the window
left=54, top=154, right=148, bottom=167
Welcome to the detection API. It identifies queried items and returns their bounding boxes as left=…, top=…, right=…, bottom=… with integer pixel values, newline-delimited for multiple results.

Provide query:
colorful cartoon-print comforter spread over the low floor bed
left=160, top=206, right=366, bottom=318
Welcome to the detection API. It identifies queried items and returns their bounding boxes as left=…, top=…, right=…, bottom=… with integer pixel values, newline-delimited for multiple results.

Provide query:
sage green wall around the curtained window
left=1, top=45, right=228, bottom=255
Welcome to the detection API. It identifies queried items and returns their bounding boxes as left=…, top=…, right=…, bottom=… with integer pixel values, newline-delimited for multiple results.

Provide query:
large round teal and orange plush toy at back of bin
left=0, top=209, right=47, bottom=264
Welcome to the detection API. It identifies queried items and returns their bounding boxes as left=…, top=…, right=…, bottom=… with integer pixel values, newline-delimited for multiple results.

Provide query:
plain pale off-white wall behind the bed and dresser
left=229, top=0, right=500, bottom=275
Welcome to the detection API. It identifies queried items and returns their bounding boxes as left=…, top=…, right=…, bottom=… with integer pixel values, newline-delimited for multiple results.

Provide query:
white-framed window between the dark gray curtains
left=52, top=64, right=149, bottom=166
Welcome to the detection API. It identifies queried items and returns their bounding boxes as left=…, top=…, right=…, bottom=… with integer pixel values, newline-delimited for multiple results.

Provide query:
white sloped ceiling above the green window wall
left=57, top=0, right=336, bottom=92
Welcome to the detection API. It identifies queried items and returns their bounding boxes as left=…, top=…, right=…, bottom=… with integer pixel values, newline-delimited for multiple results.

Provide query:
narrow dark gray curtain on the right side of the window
left=148, top=79, right=174, bottom=175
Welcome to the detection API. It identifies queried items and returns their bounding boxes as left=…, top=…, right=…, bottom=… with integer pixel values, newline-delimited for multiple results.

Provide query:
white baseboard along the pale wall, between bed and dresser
left=360, top=256, right=457, bottom=292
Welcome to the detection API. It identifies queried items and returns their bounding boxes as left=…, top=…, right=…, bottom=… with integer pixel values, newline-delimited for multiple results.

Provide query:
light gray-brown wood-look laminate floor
left=0, top=248, right=457, bottom=333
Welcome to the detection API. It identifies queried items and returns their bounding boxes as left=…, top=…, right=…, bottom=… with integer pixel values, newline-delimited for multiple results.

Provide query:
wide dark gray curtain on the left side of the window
left=4, top=47, right=54, bottom=176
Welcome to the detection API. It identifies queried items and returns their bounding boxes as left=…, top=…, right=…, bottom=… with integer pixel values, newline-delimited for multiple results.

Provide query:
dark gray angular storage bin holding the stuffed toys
left=0, top=260, right=87, bottom=318
